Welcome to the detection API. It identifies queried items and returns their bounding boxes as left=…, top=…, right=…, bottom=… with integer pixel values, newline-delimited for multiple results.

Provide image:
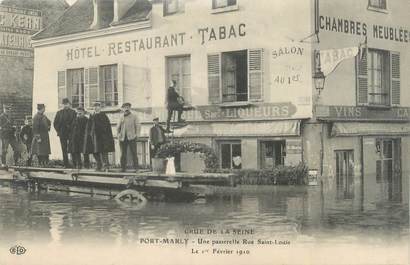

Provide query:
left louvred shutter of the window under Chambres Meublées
left=356, top=50, right=368, bottom=106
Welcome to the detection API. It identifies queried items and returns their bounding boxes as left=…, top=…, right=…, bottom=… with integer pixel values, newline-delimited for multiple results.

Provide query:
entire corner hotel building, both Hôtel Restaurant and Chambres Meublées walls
left=33, top=0, right=410, bottom=202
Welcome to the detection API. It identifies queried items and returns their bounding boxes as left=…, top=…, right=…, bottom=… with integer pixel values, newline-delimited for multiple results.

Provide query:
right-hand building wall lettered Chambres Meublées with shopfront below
left=303, top=0, right=410, bottom=202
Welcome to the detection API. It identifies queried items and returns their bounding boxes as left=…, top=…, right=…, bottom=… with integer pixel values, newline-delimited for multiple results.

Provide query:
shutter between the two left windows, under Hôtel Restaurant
left=84, top=67, right=99, bottom=108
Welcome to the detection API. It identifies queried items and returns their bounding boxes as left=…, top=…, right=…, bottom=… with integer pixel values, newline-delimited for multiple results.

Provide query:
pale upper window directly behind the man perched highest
left=167, top=55, right=191, bottom=102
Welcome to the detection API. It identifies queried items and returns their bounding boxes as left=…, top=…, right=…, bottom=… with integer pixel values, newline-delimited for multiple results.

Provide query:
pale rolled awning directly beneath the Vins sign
left=331, top=122, right=410, bottom=136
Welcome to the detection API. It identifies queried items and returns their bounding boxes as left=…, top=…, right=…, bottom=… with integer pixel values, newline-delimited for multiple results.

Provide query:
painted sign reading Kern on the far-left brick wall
left=0, top=5, right=42, bottom=57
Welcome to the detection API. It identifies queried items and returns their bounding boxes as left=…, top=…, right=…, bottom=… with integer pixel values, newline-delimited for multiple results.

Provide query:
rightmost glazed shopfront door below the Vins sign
left=376, top=139, right=401, bottom=201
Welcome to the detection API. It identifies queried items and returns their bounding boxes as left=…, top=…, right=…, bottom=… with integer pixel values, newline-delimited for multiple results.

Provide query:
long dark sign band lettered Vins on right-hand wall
left=316, top=105, right=410, bottom=122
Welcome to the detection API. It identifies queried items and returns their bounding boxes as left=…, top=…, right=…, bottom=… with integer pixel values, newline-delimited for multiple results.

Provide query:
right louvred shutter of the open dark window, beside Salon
left=248, top=49, right=263, bottom=101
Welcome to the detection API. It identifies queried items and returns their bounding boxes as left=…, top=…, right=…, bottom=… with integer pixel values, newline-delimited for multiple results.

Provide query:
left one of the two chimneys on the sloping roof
left=90, top=0, right=114, bottom=29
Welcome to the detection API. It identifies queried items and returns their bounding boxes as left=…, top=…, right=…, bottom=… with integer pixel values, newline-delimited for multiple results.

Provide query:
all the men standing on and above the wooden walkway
left=0, top=80, right=188, bottom=171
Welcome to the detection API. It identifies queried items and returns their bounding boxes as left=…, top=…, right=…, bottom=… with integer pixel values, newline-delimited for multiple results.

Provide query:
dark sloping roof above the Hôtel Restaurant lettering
left=32, top=0, right=152, bottom=40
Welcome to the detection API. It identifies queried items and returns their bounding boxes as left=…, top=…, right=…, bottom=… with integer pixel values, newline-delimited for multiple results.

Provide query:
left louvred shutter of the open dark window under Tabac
left=208, top=53, right=221, bottom=104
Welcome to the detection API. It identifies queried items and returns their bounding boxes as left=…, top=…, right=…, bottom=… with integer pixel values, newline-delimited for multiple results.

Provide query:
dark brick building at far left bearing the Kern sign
left=0, top=0, right=68, bottom=127
